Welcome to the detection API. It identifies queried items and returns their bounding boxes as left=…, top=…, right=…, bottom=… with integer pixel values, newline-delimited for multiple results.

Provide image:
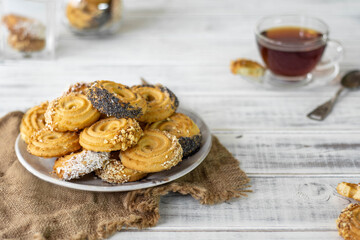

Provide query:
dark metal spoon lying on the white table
left=307, top=70, right=360, bottom=121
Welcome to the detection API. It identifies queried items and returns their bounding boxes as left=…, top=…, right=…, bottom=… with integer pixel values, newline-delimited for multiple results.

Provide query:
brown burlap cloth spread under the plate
left=0, top=112, right=249, bottom=239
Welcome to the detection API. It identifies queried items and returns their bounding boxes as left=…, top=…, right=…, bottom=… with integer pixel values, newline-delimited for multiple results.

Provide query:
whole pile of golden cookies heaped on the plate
left=20, top=80, right=201, bottom=183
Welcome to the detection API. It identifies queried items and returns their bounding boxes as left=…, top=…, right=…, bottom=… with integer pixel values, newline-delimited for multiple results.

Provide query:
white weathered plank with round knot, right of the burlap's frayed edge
left=153, top=176, right=358, bottom=231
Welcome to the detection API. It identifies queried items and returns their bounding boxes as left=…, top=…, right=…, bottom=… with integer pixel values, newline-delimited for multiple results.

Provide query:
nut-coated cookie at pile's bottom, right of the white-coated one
left=95, top=159, right=147, bottom=183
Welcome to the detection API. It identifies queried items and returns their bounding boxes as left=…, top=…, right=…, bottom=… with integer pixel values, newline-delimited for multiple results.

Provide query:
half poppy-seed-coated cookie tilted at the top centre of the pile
left=87, top=81, right=147, bottom=119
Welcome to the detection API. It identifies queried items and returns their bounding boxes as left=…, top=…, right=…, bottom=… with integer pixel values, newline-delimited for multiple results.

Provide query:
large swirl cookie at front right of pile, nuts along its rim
left=120, top=130, right=183, bottom=172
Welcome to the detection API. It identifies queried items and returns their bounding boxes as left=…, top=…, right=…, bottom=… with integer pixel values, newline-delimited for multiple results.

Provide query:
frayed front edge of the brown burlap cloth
left=34, top=173, right=252, bottom=240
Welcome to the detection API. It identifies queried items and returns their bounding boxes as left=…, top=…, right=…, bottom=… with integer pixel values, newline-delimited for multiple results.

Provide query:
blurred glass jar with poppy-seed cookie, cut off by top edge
left=63, top=0, right=123, bottom=35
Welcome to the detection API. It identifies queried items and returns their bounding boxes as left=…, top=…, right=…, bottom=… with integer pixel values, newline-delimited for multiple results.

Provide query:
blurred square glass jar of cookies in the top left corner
left=0, top=0, right=57, bottom=60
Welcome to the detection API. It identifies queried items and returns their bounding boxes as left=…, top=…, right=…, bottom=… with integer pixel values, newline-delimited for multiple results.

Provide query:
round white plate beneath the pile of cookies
left=15, top=109, right=211, bottom=192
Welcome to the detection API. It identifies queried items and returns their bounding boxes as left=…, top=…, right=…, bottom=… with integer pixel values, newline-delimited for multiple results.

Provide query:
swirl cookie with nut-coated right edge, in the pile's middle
left=80, top=118, right=142, bottom=152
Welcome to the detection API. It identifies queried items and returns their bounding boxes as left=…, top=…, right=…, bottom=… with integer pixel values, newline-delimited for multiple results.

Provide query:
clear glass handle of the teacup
left=315, top=40, right=344, bottom=71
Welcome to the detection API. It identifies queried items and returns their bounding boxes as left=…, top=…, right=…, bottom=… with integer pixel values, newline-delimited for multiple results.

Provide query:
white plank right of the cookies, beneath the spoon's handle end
left=180, top=94, right=360, bottom=131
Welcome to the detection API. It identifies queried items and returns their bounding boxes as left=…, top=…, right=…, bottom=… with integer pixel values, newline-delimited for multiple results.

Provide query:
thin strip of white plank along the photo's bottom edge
left=109, top=229, right=342, bottom=240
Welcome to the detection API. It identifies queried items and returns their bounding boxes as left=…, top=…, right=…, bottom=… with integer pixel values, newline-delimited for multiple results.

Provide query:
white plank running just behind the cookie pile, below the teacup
left=0, top=64, right=357, bottom=94
